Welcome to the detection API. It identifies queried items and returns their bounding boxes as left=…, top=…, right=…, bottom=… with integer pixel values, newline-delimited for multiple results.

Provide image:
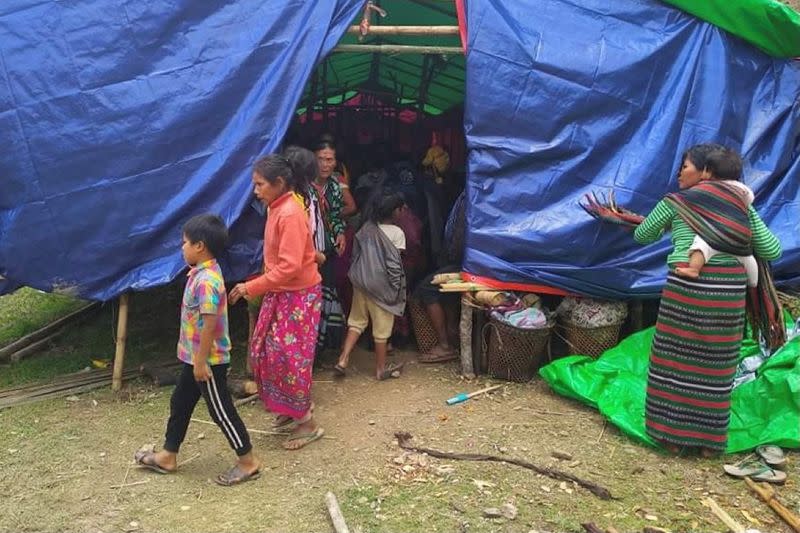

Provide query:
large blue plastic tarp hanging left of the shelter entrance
left=0, top=0, right=364, bottom=299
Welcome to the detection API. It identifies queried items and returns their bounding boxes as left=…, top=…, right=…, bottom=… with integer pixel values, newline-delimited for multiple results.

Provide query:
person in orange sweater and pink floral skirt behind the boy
left=229, top=155, right=324, bottom=450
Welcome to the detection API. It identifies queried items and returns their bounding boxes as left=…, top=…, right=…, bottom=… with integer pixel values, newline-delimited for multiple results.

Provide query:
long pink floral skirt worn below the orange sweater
left=250, top=285, right=322, bottom=418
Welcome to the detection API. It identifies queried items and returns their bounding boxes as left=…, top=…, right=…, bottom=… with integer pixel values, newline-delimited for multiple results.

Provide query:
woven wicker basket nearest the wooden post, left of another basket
left=486, top=318, right=553, bottom=383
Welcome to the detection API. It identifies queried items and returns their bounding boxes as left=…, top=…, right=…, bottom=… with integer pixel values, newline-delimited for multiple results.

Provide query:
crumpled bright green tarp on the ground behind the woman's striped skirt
left=539, top=328, right=800, bottom=453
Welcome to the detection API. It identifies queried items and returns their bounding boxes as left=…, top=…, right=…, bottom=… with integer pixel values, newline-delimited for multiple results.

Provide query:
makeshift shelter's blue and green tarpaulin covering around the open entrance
left=0, top=0, right=800, bottom=299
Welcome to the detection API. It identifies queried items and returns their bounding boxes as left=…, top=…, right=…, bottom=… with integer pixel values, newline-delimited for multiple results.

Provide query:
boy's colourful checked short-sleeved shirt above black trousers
left=178, top=259, right=231, bottom=365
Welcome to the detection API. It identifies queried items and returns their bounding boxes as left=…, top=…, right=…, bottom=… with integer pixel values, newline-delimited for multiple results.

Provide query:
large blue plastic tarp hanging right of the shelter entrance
left=464, top=0, right=800, bottom=298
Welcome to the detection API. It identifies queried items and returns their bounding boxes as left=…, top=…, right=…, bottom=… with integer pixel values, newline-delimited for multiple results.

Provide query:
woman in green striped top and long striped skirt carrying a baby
left=634, top=144, right=781, bottom=457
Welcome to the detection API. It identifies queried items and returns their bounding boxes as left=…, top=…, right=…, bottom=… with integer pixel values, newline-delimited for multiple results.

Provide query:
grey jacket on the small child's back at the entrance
left=348, top=222, right=406, bottom=316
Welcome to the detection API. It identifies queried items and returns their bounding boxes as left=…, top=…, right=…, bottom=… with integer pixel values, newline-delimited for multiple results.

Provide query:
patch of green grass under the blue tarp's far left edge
left=0, top=287, right=86, bottom=346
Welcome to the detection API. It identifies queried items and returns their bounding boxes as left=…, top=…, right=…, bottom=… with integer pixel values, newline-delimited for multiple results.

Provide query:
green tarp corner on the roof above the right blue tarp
left=663, top=0, right=800, bottom=57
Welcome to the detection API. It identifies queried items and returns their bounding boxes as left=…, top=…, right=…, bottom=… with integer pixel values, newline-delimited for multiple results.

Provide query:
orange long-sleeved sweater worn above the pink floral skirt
left=246, top=192, right=322, bottom=296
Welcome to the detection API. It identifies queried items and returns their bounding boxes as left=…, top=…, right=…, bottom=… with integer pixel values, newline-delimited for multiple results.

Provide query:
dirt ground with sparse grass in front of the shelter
left=0, top=344, right=800, bottom=532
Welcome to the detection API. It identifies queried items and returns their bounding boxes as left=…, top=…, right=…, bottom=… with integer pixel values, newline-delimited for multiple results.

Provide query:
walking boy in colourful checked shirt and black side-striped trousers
left=134, top=215, right=261, bottom=486
